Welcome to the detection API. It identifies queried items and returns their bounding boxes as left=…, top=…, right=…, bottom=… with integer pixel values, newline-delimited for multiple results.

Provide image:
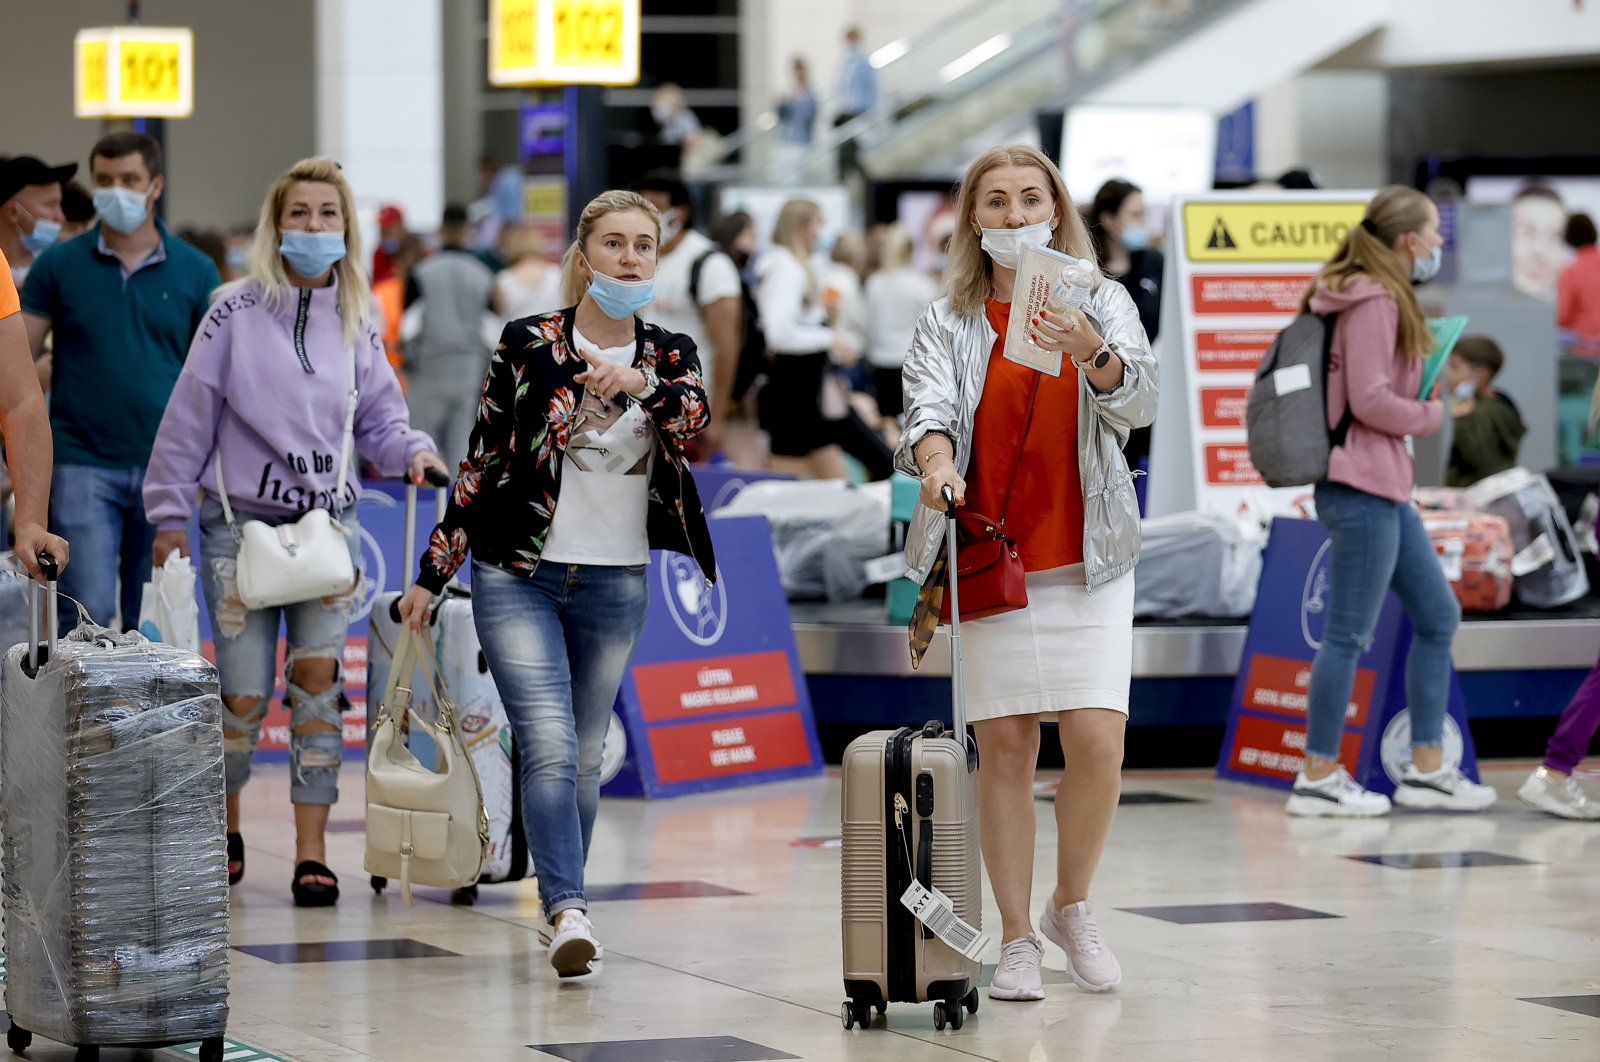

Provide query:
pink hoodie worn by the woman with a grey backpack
left=1310, top=277, right=1445, bottom=502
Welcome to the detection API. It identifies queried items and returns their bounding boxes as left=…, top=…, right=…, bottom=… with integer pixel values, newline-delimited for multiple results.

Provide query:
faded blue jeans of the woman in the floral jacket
left=472, top=561, right=650, bottom=921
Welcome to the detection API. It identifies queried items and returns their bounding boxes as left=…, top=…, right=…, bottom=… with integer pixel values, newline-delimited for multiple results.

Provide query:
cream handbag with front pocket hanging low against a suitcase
left=366, top=627, right=490, bottom=907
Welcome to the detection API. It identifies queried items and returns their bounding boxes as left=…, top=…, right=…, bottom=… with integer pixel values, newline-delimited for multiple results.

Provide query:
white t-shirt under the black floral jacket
left=539, top=328, right=656, bottom=566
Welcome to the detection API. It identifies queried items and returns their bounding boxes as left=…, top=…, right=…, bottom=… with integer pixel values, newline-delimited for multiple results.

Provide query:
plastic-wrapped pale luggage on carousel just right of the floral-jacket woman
left=717, top=481, right=890, bottom=601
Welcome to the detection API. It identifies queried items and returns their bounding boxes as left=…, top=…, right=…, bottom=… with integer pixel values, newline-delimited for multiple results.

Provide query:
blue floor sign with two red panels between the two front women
left=603, top=515, right=822, bottom=797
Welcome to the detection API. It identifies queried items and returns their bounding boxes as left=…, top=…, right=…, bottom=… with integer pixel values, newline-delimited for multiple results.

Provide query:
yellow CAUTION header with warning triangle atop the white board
left=1184, top=200, right=1366, bottom=262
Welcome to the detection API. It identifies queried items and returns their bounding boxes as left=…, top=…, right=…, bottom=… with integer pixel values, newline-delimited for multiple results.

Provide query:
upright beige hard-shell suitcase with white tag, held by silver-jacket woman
left=840, top=486, right=982, bottom=1030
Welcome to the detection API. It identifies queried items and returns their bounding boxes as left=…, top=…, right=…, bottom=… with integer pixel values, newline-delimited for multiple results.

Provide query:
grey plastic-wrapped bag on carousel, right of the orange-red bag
left=1461, top=469, right=1589, bottom=608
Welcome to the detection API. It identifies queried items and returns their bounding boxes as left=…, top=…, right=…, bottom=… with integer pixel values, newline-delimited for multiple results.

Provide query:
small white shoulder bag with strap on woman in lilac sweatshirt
left=214, top=335, right=358, bottom=609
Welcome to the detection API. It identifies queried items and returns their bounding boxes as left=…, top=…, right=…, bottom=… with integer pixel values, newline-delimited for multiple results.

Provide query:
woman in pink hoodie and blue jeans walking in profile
left=1288, top=184, right=1494, bottom=817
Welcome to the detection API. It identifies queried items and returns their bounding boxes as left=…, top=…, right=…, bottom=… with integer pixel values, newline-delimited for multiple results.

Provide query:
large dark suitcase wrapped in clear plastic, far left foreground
left=0, top=559, right=229, bottom=1062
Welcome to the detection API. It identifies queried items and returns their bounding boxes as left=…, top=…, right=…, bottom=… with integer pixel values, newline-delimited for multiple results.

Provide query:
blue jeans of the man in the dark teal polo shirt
left=50, top=464, right=155, bottom=635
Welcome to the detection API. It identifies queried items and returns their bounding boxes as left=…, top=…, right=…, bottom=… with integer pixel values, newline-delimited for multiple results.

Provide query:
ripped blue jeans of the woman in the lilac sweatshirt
left=200, top=496, right=360, bottom=804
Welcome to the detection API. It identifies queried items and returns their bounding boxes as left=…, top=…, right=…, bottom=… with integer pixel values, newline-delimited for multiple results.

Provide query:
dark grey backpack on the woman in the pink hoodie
left=1245, top=313, right=1355, bottom=486
